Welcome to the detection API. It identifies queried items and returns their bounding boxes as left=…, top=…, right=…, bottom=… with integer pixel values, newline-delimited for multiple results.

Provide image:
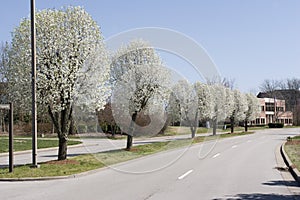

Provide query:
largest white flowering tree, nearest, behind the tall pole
left=8, top=7, right=109, bottom=160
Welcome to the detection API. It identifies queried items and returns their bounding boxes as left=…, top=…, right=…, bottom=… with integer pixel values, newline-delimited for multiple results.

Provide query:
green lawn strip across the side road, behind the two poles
left=0, top=137, right=81, bottom=153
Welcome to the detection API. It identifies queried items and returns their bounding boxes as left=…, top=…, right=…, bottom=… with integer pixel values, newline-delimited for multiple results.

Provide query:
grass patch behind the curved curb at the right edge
left=284, top=136, right=300, bottom=171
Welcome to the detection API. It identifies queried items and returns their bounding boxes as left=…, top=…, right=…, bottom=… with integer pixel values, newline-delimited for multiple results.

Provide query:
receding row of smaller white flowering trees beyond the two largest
left=168, top=80, right=260, bottom=137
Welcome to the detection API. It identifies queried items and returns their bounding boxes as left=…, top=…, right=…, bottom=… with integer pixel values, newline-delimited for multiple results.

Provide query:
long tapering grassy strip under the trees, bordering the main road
left=0, top=132, right=253, bottom=178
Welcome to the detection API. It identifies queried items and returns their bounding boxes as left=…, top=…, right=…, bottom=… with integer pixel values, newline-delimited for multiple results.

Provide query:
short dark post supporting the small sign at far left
left=8, top=103, right=14, bottom=172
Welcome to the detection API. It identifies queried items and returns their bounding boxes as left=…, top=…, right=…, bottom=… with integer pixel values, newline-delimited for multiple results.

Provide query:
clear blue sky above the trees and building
left=0, top=0, right=300, bottom=92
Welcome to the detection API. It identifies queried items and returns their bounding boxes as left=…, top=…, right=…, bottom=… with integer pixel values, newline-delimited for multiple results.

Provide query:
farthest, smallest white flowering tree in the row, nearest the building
left=244, top=93, right=260, bottom=132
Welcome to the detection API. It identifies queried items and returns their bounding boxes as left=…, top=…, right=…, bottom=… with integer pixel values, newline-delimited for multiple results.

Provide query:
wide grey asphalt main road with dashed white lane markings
left=0, top=129, right=300, bottom=200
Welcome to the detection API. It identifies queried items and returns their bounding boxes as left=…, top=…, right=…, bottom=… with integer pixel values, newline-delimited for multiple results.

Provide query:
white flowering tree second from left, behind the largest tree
left=111, top=40, right=170, bottom=150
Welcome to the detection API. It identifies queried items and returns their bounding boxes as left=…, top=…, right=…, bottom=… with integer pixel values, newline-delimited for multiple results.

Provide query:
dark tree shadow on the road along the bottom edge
left=213, top=193, right=300, bottom=200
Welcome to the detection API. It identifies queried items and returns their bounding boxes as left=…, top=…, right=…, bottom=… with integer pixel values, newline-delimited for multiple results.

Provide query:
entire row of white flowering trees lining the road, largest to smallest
left=0, top=7, right=258, bottom=160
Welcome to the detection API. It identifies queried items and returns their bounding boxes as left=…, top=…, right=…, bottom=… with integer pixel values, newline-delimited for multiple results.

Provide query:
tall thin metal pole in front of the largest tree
left=30, top=0, right=38, bottom=167
